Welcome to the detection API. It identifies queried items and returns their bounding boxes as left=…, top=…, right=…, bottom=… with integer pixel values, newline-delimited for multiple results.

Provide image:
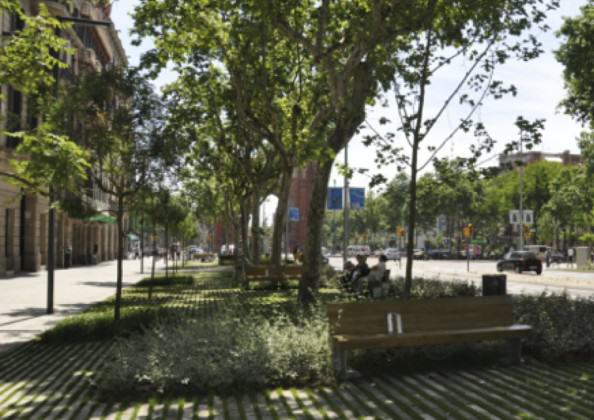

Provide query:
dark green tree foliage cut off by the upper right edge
left=556, top=0, right=594, bottom=128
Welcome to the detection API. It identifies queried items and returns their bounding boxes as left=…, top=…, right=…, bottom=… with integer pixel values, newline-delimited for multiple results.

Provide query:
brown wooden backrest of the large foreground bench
left=328, top=296, right=513, bottom=335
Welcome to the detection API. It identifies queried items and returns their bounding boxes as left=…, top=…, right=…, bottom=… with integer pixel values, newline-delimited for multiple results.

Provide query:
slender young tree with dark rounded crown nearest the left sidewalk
left=56, top=68, right=164, bottom=321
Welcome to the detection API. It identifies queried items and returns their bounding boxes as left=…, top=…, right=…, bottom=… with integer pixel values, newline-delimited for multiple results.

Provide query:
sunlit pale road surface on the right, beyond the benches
left=330, top=257, right=594, bottom=297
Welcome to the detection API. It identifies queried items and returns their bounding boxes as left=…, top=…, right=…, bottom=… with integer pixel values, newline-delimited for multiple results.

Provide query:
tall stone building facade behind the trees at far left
left=0, top=0, right=127, bottom=276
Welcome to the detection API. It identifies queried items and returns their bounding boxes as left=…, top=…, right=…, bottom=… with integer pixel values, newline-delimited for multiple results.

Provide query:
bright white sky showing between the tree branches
left=112, top=0, right=586, bottom=199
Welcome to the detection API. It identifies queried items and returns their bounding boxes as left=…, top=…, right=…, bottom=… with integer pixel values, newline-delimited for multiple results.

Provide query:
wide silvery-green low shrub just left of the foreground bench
left=98, top=305, right=332, bottom=396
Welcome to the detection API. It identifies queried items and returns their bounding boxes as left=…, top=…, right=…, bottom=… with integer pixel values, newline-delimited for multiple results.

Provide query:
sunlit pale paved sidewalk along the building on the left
left=0, top=258, right=162, bottom=351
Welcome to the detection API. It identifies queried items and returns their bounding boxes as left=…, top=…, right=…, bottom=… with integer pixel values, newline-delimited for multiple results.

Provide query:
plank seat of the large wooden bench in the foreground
left=334, top=324, right=532, bottom=350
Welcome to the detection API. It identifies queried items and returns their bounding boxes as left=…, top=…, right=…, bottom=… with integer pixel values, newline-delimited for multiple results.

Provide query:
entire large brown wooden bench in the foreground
left=328, top=296, right=532, bottom=377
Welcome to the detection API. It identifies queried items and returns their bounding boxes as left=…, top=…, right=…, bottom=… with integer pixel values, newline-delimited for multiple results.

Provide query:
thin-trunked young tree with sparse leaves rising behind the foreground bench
left=360, top=0, right=558, bottom=295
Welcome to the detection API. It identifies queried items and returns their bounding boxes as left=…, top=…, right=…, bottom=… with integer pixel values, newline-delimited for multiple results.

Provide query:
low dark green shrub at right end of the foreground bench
left=514, top=292, right=594, bottom=361
